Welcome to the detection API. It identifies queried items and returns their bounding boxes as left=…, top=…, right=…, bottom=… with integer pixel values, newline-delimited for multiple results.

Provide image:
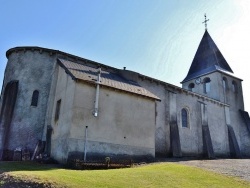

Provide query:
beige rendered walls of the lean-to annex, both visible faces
left=51, top=67, right=155, bottom=163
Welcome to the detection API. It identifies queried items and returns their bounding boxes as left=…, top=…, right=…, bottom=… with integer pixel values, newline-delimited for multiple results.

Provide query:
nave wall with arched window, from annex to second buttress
left=139, top=74, right=203, bottom=156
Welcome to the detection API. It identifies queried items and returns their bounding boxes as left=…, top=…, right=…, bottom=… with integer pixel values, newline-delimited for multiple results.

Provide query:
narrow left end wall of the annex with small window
left=50, top=66, right=75, bottom=163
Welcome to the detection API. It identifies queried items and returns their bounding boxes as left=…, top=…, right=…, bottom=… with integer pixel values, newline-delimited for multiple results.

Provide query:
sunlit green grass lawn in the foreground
left=0, top=162, right=250, bottom=188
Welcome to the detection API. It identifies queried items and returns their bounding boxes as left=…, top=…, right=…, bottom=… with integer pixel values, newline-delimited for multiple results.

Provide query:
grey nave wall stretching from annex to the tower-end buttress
left=139, top=75, right=231, bottom=156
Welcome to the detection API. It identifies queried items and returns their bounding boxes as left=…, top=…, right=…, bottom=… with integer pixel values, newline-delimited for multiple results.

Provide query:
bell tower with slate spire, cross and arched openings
left=181, top=17, right=244, bottom=110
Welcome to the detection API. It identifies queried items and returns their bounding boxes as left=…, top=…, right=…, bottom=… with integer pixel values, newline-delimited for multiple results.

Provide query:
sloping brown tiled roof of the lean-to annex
left=58, top=59, right=160, bottom=100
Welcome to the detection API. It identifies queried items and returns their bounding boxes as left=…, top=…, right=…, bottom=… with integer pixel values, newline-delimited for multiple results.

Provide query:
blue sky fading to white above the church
left=0, top=0, right=250, bottom=110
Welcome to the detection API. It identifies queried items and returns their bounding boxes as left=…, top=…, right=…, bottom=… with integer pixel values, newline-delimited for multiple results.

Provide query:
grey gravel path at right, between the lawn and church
left=172, top=159, right=250, bottom=181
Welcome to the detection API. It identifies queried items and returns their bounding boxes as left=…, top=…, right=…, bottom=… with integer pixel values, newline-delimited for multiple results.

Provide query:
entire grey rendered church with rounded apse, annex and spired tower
left=0, top=30, right=250, bottom=163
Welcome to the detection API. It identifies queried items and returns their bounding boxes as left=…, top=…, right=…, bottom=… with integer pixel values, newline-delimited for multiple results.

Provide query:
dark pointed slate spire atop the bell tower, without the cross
left=182, top=30, right=233, bottom=83
